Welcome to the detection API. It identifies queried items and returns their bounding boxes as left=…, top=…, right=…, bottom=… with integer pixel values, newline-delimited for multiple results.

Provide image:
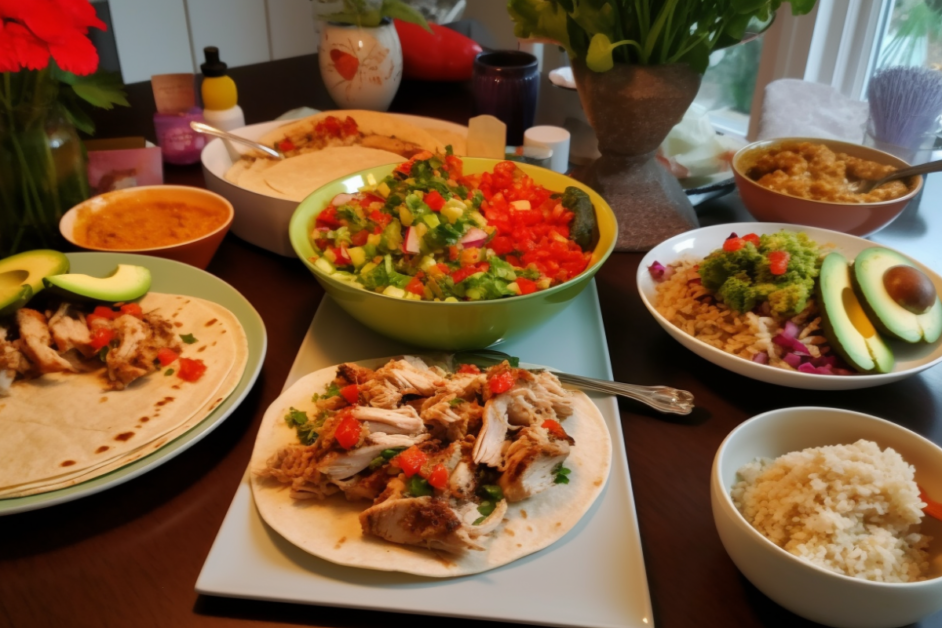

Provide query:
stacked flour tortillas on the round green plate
left=0, top=293, right=248, bottom=498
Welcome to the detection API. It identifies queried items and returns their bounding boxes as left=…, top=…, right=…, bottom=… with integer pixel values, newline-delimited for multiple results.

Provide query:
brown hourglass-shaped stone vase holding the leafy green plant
left=572, top=59, right=700, bottom=251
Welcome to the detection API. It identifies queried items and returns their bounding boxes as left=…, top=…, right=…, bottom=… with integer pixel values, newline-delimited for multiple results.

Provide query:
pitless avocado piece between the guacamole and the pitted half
left=817, top=253, right=895, bottom=373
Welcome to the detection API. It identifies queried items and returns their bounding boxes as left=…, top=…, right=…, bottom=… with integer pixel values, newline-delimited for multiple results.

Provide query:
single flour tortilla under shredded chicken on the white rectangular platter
left=249, top=359, right=612, bottom=578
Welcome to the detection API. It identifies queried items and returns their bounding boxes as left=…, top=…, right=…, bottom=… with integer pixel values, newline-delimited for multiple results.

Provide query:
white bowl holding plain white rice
left=710, top=407, right=942, bottom=628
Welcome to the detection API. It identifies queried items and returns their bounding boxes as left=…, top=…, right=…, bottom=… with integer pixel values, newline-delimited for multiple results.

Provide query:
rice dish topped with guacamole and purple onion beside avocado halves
left=649, top=231, right=852, bottom=375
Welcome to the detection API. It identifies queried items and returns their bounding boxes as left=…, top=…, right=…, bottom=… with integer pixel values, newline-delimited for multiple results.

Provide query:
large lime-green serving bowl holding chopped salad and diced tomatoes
left=289, top=157, right=618, bottom=351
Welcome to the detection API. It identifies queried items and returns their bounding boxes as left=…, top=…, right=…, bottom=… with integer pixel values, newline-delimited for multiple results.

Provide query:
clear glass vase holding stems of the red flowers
left=0, top=70, right=89, bottom=258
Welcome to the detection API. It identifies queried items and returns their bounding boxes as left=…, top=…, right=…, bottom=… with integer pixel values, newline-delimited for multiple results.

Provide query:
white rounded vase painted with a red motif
left=317, top=19, right=402, bottom=111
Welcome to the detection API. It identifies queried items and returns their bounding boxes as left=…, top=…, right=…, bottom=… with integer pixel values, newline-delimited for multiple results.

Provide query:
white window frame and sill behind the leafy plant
left=710, top=0, right=893, bottom=140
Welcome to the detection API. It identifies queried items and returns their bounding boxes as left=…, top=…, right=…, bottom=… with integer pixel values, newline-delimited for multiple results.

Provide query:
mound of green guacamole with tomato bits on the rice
left=699, top=231, right=821, bottom=316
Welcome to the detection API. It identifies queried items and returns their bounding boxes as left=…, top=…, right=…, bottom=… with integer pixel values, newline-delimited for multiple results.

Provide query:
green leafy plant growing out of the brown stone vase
left=507, top=0, right=815, bottom=74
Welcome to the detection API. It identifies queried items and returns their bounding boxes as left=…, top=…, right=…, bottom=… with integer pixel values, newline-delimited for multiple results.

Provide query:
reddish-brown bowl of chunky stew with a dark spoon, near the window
left=733, top=137, right=923, bottom=237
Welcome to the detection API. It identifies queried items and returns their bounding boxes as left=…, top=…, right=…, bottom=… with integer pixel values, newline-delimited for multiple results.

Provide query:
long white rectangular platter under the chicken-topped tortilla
left=196, top=281, right=653, bottom=628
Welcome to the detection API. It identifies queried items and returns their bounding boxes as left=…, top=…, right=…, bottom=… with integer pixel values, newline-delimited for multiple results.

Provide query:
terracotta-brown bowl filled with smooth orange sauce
left=59, top=185, right=234, bottom=268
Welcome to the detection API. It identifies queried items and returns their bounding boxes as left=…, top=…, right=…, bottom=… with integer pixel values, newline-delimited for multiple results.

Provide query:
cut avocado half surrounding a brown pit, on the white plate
left=852, top=246, right=942, bottom=343
